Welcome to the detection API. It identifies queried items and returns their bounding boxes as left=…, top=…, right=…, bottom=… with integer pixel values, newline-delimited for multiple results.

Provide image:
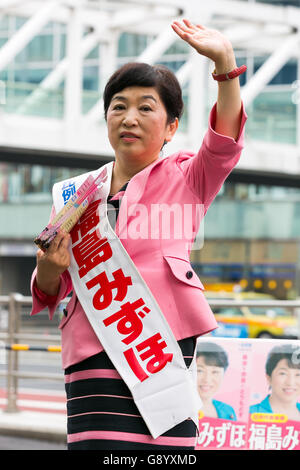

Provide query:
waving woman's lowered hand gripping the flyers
left=36, top=231, right=71, bottom=296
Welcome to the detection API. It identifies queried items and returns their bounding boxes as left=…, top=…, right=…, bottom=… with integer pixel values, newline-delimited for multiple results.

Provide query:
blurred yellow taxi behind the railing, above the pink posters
left=205, top=291, right=300, bottom=339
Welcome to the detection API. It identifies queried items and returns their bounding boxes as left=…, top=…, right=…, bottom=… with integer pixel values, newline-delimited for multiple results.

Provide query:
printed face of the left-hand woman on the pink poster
left=197, top=356, right=224, bottom=400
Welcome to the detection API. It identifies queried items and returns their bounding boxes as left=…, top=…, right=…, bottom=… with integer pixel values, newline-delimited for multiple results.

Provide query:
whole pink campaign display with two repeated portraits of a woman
left=196, top=336, right=300, bottom=450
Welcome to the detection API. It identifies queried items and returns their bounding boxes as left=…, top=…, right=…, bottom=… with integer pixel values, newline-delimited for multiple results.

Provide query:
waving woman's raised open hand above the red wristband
left=171, top=19, right=234, bottom=69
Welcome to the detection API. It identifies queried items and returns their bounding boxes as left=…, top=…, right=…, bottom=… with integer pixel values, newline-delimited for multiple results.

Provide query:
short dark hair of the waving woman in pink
left=103, top=62, right=183, bottom=123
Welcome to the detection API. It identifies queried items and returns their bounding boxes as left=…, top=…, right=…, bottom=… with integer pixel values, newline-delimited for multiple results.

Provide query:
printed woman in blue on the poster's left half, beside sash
left=197, top=341, right=236, bottom=421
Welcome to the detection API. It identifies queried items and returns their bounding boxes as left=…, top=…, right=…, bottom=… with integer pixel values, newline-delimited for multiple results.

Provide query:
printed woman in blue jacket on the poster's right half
left=250, top=344, right=300, bottom=421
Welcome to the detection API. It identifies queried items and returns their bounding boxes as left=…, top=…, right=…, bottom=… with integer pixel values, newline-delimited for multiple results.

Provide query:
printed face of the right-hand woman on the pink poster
left=267, top=359, right=300, bottom=404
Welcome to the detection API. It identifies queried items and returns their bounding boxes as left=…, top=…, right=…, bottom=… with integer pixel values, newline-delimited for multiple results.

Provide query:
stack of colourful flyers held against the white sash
left=34, top=168, right=107, bottom=251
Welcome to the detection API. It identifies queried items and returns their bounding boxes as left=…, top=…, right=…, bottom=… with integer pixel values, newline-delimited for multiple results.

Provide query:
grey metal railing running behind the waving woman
left=0, top=293, right=300, bottom=413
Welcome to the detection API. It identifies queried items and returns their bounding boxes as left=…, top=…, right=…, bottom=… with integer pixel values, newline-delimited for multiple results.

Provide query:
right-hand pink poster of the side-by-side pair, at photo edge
left=248, top=339, right=300, bottom=450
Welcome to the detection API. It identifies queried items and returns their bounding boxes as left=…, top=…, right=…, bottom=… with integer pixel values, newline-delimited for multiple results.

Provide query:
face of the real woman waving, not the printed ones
left=107, top=86, right=178, bottom=163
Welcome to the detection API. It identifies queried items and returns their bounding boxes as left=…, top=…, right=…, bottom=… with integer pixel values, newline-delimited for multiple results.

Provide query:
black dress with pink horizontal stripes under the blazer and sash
left=65, top=184, right=197, bottom=450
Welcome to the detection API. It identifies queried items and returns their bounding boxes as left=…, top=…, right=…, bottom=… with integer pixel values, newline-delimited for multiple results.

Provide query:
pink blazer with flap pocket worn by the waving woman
left=31, top=105, right=247, bottom=368
